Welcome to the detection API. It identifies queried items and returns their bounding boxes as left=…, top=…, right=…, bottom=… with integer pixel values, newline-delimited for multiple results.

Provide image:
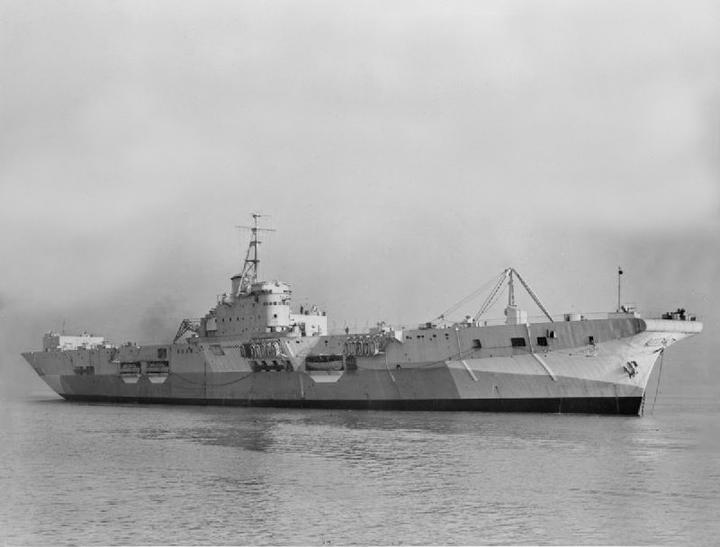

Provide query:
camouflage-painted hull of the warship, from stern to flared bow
left=24, top=318, right=702, bottom=415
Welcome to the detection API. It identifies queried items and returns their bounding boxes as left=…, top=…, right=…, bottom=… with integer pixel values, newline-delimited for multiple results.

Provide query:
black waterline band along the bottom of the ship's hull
left=62, top=394, right=642, bottom=416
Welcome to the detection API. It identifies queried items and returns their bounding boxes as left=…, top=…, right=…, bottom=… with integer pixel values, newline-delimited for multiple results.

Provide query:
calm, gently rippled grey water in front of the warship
left=0, top=392, right=720, bottom=545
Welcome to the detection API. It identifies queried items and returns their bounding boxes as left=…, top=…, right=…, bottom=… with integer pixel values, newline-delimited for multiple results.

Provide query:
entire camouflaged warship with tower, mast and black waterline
left=23, top=215, right=702, bottom=415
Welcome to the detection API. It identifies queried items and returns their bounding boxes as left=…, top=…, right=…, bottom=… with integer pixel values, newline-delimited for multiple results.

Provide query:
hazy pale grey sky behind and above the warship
left=0, top=0, right=720, bottom=394
